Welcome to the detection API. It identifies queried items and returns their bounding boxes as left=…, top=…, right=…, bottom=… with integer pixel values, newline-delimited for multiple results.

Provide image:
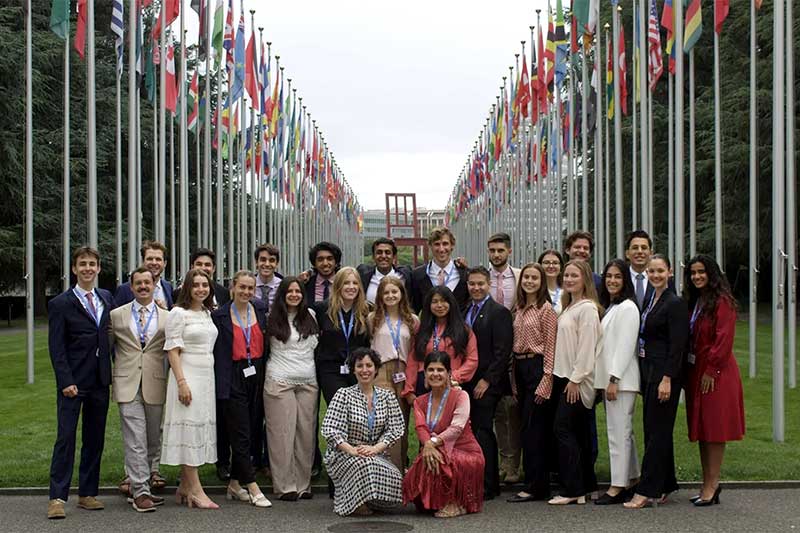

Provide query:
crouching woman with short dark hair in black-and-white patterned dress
left=322, top=348, right=404, bottom=516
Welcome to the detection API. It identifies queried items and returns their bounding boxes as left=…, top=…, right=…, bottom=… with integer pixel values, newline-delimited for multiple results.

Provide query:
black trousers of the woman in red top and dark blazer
left=221, top=358, right=264, bottom=485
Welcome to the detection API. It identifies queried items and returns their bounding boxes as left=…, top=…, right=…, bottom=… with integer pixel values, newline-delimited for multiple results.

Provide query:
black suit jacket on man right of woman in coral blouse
left=464, top=297, right=514, bottom=388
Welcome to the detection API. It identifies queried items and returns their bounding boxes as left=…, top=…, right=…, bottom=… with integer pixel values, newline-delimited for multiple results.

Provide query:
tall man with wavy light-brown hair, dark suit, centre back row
left=410, top=228, right=469, bottom=314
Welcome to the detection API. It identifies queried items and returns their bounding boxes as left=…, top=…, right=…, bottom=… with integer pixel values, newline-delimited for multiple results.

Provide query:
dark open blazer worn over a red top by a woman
left=211, top=300, right=269, bottom=400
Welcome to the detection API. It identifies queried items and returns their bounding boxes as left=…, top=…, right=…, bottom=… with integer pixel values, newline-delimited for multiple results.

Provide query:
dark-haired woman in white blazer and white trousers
left=594, top=259, right=639, bottom=505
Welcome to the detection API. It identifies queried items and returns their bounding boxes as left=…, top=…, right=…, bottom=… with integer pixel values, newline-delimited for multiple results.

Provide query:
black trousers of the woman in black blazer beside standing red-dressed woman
left=636, top=378, right=681, bottom=498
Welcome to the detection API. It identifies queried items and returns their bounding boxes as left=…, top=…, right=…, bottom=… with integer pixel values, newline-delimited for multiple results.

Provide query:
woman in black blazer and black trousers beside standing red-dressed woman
left=625, top=254, right=689, bottom=509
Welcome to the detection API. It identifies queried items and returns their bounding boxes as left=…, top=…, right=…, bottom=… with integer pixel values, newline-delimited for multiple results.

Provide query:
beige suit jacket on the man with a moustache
left=109, top=302, right=169, bottom=405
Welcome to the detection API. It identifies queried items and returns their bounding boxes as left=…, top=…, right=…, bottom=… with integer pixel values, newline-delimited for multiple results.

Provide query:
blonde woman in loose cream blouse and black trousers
left=548, top=260, right=603, bottom=505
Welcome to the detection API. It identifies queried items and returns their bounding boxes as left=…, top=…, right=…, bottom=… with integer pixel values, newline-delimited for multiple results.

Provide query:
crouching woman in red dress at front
left=403, top=352, right=485, bottom=518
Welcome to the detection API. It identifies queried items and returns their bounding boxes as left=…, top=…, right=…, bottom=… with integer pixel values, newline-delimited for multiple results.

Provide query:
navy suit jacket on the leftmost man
left=47, top=287, right=114, bottom=392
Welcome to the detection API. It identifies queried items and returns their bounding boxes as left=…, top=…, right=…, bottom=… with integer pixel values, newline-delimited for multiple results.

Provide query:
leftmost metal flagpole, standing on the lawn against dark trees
left=25, top=0, right=33, bottom=385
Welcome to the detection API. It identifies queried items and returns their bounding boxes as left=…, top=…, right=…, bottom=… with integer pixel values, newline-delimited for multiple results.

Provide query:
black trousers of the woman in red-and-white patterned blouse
left=514, top=355, right=553, bottom=499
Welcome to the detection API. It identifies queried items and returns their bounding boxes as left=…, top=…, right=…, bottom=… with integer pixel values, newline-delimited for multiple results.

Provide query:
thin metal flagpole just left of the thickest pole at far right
left=747, top=0, right=759, bottom=378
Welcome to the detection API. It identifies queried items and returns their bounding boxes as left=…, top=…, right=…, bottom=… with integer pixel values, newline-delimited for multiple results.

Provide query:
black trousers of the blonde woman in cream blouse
left=553, top=378, right=597, bottom=498
